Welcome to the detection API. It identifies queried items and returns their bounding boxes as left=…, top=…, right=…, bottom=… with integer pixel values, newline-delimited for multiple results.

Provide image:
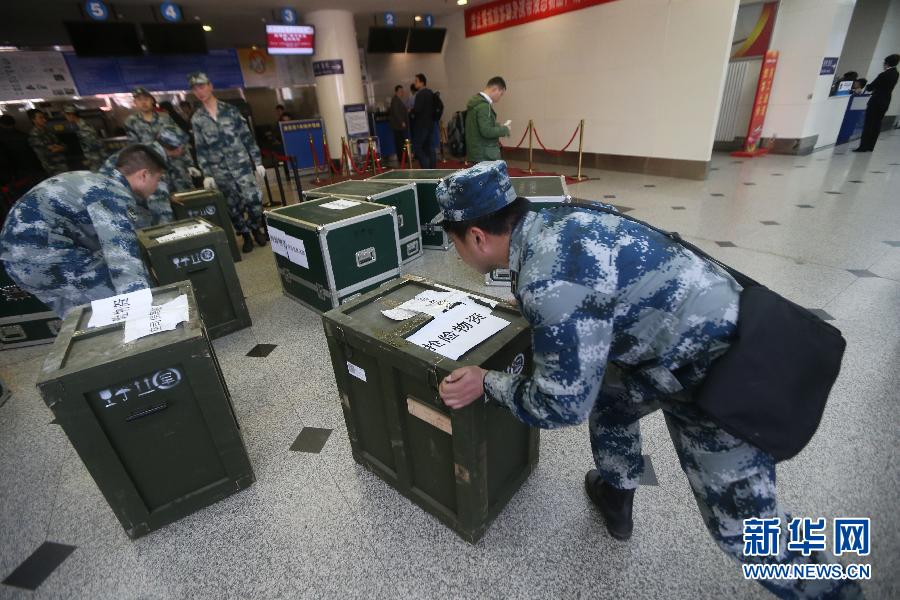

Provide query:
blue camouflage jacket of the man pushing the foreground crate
left=484, top=207, right=741, bottom=428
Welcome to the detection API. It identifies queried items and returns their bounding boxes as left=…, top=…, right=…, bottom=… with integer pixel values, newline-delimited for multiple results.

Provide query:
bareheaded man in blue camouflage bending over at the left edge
left=0, top=145, right=165, bottom=317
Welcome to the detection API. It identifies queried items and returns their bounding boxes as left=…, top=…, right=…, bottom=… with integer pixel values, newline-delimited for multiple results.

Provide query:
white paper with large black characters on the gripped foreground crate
left=406, top=304, right=509, bottom=360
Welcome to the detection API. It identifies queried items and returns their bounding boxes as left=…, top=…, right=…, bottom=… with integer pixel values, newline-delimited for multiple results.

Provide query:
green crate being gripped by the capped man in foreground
left=323, top=276, right=539, bottom=543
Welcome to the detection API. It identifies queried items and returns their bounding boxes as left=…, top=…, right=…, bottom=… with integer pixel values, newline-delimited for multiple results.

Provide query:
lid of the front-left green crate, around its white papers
left=38, top=281, right=203, bottom=385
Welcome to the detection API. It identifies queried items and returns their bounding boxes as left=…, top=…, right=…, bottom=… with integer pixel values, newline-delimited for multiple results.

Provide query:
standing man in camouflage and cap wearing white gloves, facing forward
left=188, top=73, right=268, bottom=252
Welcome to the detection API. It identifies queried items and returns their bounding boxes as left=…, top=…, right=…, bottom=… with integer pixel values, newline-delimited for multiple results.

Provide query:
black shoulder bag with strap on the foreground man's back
left=572, top=199, right=847, bottom=461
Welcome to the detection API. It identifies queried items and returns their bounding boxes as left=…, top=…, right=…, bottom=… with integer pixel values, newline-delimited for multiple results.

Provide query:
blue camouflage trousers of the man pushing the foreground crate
left=589, top=372, right=862, bottom=599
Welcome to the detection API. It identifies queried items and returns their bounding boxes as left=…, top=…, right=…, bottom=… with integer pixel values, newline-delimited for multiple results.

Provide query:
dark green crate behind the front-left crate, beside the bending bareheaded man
left=137, top=217, right=253, bottom=339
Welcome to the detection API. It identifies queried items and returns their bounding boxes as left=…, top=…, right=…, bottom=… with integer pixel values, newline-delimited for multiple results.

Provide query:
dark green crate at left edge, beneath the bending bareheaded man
left=0, top=262, right=62, bottom=350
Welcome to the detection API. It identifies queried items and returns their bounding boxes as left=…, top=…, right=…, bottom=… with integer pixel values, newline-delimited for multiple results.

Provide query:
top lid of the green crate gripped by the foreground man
left=322, top=275, right=529, bottom=370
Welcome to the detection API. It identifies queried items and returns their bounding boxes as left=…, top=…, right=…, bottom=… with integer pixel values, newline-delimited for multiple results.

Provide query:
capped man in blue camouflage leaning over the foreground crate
left=437, top=161, right=861, bottom=598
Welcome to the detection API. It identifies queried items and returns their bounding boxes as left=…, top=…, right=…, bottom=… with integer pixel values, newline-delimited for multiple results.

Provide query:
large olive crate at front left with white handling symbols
left=37, top=281, right=255, bottom=538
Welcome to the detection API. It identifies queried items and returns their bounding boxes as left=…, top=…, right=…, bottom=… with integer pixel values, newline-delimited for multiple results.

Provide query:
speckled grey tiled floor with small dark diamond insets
left=0, top=132, right=900, bottom=599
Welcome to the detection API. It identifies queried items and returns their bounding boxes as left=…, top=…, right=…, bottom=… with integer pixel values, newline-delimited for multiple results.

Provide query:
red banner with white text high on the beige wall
left=466, top=0, right=615, bottom=37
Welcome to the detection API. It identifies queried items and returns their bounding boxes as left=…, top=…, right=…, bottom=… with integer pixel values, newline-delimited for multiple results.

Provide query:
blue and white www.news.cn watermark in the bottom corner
left=741, top=517, right=872, bottom=579
